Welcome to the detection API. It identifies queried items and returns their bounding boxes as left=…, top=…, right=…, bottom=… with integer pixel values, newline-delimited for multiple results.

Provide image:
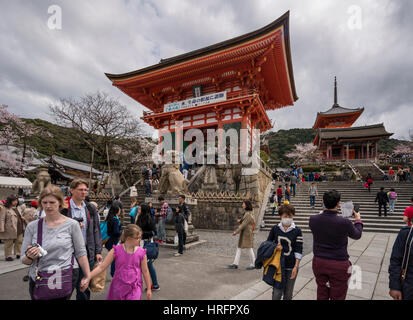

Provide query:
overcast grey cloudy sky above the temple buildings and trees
left=0, top=0, right=413, bottom=138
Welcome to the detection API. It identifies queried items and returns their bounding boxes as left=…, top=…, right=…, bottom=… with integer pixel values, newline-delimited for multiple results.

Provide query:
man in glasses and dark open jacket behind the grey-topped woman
left=61, top=179, right=103, bottom=300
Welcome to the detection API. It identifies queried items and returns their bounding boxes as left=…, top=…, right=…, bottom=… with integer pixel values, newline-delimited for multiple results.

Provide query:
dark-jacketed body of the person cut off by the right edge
left=389, top=227, right=413, bottom=300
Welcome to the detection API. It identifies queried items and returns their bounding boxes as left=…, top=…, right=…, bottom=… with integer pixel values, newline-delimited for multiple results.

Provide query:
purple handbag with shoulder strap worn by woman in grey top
left=33, top=219, right=74, bottom=300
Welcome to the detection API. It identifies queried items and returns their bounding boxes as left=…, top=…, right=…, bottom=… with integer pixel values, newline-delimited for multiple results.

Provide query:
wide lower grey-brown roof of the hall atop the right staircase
left=314, top=123, right=393, bottom=144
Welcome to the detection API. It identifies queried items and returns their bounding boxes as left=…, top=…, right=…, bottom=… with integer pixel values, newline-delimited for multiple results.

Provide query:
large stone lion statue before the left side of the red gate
left=158, top=152, right=189, bottom=195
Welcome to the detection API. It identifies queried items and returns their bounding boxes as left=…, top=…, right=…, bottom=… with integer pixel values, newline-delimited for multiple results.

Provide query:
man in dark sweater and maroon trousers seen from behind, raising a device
left=309, top=190, right=363, bottom=300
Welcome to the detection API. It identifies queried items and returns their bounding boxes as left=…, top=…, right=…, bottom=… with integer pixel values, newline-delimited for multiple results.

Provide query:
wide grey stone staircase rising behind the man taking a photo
left=261, top=181, right=413, bottom=233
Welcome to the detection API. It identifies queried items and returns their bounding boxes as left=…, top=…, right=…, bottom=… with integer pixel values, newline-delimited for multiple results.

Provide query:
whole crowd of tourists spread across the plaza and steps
left=0, top=166, right=413, bottom=300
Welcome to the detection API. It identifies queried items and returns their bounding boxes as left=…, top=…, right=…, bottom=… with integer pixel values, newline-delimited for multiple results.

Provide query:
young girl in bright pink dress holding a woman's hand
left=81, top=224, right=152, bottom=300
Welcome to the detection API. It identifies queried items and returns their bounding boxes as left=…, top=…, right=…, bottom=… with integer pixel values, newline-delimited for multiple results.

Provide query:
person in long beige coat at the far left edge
left=0, top=196, right=24, bottom=261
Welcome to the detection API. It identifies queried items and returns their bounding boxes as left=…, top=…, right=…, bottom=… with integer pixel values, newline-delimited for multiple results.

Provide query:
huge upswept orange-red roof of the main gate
left=105, top=11, right=298, bottom=109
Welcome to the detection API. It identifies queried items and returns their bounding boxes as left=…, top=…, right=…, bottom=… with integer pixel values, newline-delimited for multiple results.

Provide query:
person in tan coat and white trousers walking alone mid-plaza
left=228, top=200, right=255, bottom=270
